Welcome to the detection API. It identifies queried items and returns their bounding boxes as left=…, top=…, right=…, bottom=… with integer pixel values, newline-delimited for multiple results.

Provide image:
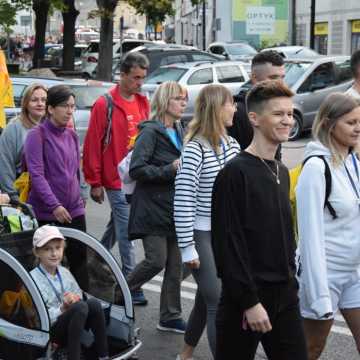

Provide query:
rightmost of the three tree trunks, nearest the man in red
left=96, top=0, right=118, bottom=81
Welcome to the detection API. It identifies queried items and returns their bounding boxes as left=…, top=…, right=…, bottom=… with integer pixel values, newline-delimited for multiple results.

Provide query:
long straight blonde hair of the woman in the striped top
left=185, top=85, right=233, bottom=151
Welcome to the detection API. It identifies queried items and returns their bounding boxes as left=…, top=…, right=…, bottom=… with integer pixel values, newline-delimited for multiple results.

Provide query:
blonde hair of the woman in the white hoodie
left=312, top=92, right=360, bottom=165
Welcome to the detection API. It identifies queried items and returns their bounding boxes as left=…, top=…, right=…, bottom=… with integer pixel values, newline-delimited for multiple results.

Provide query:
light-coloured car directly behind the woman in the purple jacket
left=5, top=76, right=115, bottom=145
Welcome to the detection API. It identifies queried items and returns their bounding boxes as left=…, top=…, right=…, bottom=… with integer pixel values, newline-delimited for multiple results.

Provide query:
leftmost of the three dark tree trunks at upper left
left=33, top=0, right=50, bottom=69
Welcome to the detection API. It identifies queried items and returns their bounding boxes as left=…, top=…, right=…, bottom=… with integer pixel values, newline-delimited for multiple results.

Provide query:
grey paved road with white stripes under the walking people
left=87, top=137, right=359, bottom=360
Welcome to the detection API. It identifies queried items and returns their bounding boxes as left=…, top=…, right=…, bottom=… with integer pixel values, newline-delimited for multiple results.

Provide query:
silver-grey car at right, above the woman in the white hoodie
left=285, top=56, right=352, bottom=140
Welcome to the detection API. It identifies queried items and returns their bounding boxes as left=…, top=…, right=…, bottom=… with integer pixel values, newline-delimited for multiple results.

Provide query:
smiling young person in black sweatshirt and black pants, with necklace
left=212, top=81, right=307, bottom=360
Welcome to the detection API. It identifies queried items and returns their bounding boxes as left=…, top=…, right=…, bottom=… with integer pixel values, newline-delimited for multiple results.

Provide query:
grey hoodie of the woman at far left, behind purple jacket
left=0, top=117, right=30, bottom=199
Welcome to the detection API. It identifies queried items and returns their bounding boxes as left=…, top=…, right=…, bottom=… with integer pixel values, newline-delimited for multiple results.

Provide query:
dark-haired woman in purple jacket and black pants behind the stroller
left=24, top=85, right=88, bottom=290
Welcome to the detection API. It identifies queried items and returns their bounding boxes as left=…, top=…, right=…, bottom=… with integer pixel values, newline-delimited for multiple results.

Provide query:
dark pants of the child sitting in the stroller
left=50, top=299, right=108, bottom=360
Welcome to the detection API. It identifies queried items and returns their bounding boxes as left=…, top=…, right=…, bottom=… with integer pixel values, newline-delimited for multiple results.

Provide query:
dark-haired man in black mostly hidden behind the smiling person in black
left=227, top=50, right=285, bottom=160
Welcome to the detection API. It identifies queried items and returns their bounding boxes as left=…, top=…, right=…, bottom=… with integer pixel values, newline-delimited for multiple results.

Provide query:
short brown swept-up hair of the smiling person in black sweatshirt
left=246, top=80, right=294, bottom=113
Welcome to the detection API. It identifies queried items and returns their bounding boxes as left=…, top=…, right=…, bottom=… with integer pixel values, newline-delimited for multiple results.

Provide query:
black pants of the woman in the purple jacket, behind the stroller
left=38, top=215, right=89, bottom=291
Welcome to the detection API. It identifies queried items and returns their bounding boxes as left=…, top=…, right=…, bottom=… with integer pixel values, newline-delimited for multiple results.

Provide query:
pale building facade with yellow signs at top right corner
left=296, top=0, right=360, bottom=55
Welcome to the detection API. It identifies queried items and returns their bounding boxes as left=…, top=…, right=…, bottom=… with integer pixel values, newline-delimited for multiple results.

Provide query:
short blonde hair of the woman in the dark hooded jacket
left=150, top=81, right=187, bottom=122
